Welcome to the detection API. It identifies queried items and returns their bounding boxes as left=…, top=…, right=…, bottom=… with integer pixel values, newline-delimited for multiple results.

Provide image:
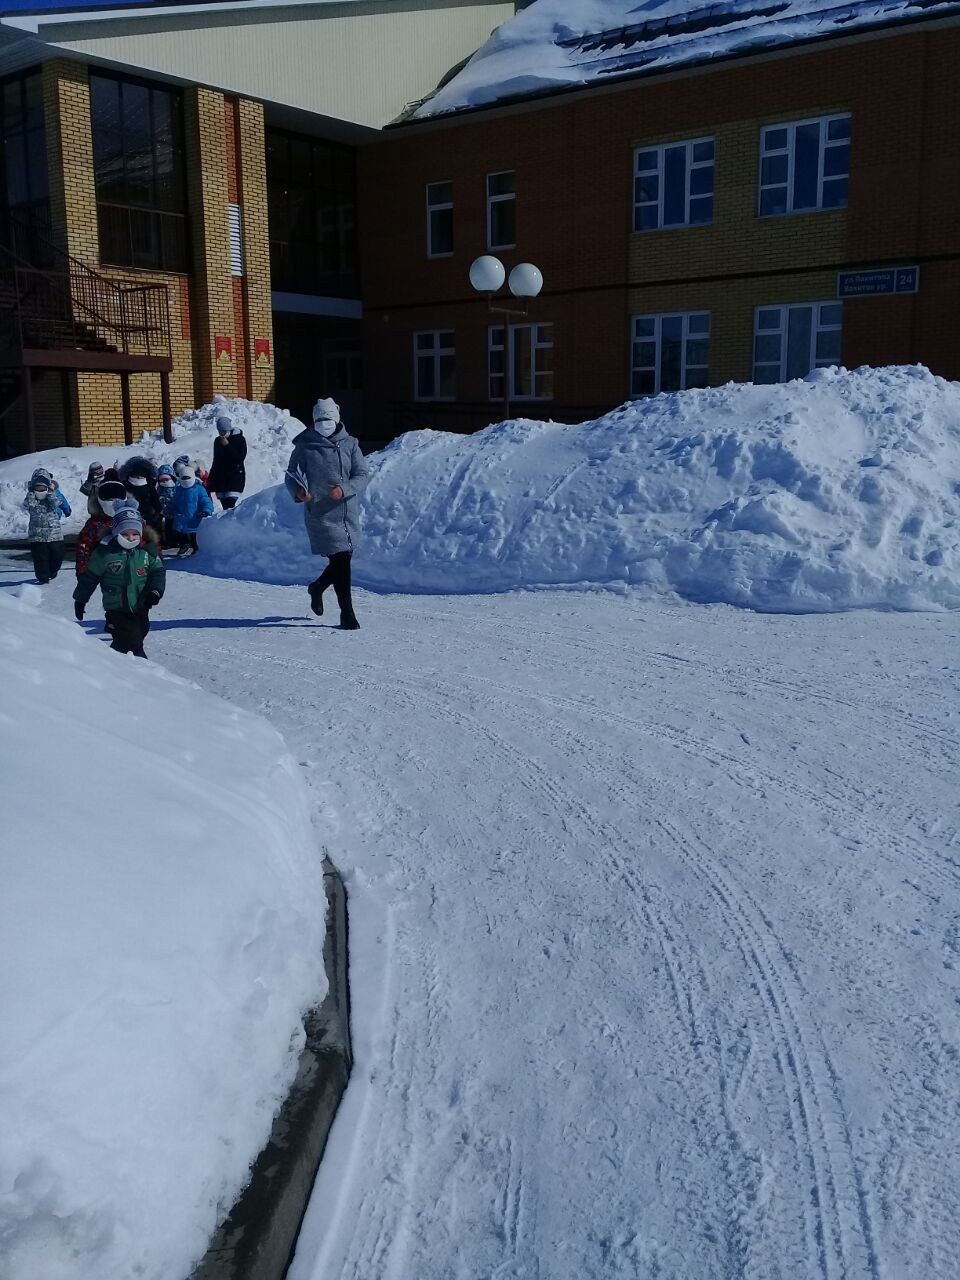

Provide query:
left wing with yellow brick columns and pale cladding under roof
left=0, top=0, right=515, bottom=457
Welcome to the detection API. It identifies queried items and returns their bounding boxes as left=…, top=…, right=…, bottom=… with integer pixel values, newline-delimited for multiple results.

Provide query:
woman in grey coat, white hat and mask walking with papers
left=284, top=399, right=370, bottom=631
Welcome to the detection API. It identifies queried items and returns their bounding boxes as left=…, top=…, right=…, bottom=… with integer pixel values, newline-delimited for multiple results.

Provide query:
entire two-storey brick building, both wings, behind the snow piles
left=0, top=0, right=960, bottom=453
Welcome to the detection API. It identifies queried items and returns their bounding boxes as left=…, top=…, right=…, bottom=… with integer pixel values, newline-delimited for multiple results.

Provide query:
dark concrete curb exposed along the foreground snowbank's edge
left=191, top=859, right=353, bottom=1280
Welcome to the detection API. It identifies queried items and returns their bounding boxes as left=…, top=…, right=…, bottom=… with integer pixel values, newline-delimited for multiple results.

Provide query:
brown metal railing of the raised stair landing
left=0, top=216, right=172, bottom=358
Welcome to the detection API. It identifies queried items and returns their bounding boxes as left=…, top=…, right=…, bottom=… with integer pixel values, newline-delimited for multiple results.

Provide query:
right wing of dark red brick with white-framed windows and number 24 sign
left=360, top=8, right=960, bottom=440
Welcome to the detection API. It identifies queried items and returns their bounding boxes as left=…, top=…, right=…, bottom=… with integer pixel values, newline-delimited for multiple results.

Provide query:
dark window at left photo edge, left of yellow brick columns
left=0, top=72, right=50, bottom=266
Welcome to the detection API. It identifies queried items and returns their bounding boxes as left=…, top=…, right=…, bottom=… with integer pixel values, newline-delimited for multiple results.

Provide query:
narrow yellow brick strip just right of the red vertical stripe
left=237, top=99, right=274, bottom=399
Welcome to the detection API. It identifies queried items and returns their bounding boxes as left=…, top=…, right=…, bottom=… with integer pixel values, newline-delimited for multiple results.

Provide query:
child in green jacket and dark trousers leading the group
left=73, top=503, right=166, bottom=658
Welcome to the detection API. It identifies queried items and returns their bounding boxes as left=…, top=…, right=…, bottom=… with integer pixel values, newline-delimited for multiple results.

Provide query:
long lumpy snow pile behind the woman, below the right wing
left=202, top=367, right=960, bottom=611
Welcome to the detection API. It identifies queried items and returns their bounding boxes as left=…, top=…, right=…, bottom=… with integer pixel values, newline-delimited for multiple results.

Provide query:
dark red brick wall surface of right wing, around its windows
left=358, top=28, right=960, bottom=434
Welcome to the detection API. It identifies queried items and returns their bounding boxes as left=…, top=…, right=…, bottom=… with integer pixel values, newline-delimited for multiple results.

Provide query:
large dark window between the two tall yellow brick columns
left=90, top=74, right=188, bottom=271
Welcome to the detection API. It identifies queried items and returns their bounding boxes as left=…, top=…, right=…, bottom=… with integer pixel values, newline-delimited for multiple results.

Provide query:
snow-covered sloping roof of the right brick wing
left=411, top=0, right=960, bottom=119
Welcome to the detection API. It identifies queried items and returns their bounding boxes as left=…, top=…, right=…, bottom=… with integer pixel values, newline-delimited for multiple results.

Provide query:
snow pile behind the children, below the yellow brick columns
left=0, top=396, right=303, bottom=540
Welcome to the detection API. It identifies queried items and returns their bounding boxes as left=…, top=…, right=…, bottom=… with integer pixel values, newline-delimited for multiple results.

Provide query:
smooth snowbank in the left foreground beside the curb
left=0, top=588, right=325, bottom=1280
